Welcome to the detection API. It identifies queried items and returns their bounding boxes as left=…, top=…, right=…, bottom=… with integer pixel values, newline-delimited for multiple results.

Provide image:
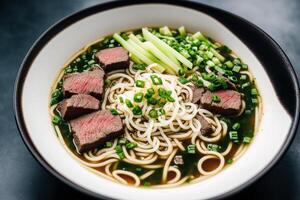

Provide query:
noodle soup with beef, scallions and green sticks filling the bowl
left=50, top=27, right=261, bottom=187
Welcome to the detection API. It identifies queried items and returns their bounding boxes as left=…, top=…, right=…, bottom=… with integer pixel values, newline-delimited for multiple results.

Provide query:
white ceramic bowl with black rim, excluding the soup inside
left=14, top=2, right=299, bottom=200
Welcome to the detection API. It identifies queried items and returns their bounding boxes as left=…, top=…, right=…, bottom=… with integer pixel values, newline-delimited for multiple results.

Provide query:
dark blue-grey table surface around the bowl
left=0, top=0, right=300, bottom=200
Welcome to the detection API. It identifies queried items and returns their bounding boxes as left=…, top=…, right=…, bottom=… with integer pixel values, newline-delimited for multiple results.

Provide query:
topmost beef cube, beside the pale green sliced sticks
left=95, top=47, right=130, bottom=71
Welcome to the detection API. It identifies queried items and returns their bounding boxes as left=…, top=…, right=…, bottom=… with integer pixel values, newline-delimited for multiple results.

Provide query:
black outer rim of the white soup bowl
left=13, top=0, right=300, bottom=198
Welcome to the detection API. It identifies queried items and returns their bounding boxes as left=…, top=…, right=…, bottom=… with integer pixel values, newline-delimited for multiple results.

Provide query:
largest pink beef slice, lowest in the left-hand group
left=70, top=110, right=123, bottom=152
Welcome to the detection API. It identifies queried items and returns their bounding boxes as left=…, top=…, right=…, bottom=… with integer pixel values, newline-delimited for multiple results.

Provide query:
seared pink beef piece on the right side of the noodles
left=200, top=90, right=242, bottom=115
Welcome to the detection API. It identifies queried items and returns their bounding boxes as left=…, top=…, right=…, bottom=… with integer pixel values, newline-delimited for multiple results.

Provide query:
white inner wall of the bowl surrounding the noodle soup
left=17, top=4, right=292, bottom=199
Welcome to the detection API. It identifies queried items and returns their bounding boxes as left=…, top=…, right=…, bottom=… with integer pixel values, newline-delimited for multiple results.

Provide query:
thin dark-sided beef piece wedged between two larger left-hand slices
left=57, top=94, right=100, bottom=120
